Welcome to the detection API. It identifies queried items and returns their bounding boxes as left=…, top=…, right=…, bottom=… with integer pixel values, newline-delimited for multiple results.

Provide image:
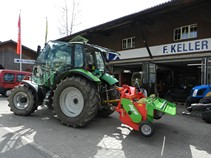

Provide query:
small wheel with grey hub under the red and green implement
left=139, top=121, right=154, bottom=137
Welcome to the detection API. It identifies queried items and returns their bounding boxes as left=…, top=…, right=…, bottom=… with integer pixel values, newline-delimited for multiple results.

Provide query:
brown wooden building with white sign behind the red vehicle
left=0, top=40, right=36, bottom=71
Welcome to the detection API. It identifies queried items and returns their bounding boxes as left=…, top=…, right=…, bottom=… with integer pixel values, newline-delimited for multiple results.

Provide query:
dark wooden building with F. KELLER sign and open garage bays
left=61, top=0, right=211, bottom=100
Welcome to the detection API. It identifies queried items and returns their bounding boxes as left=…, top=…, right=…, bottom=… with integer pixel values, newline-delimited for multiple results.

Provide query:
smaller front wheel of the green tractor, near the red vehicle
left=8, top=85, right=37, bottom=116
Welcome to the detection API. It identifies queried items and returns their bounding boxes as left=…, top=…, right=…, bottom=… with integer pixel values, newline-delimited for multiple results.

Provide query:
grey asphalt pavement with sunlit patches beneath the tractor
left=0, top=96, right=211, bottom=158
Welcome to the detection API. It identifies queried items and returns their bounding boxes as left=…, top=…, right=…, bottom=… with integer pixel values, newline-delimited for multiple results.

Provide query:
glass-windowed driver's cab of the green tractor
left=33, top=41, right=109, bottom=87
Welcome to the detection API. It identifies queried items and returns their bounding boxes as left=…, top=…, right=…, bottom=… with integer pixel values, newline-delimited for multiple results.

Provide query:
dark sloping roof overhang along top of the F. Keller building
left=58, top=0, right=206, bottom=41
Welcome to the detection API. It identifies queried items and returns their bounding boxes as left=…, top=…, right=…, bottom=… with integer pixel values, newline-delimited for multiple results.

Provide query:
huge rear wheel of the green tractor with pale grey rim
left=53, top=76, right=100, bottom=128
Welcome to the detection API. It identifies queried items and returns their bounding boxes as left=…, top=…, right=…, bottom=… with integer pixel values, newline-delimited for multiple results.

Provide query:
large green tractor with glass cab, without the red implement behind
left=8, top=41, right=119, bottom=127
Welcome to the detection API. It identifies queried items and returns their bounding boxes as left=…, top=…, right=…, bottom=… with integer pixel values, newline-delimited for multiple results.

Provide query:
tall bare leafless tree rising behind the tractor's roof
left=58, top=0, right=80, bottom=36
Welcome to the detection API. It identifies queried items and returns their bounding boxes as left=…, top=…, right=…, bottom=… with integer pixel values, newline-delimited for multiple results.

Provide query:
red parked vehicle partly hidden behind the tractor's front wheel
left=0, top=69, right=31, bottom=97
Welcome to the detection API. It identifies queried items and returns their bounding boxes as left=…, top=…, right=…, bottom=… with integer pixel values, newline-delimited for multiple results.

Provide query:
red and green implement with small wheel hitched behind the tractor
left=115, top=85, right=176, bottom=136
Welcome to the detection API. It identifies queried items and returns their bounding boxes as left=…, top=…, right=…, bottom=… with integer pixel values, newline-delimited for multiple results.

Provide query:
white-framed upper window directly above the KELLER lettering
left=174, top=24, right=197, bottom=41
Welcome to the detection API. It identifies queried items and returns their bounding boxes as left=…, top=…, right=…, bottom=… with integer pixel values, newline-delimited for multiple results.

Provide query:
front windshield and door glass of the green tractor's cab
left=32, top=41, right=72, bottom=87
